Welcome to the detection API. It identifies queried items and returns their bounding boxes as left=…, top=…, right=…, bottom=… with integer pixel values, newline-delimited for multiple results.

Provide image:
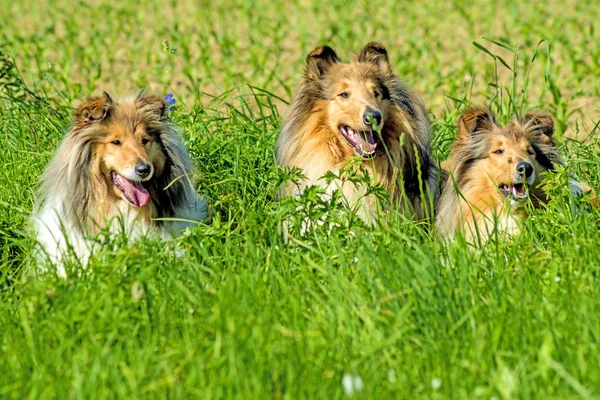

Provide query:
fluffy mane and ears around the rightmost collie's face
left=436, top=107, right=564, bottom=238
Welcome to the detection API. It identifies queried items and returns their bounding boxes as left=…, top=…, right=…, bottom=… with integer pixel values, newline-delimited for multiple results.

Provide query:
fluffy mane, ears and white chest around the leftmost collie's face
left=33, top=92, right=206, bottom=272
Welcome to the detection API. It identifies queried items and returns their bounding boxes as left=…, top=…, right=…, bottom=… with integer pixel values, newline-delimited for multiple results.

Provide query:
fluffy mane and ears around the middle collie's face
left=276, top=43, right=437, bottom=218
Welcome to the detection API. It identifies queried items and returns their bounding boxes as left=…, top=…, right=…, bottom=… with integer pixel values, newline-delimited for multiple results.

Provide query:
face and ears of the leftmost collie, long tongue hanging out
left=75, top=93, right=166, bottom=207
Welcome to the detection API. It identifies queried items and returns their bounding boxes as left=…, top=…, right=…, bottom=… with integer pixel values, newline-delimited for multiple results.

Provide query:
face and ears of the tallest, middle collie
left=306, top=43, right=391, bottom=159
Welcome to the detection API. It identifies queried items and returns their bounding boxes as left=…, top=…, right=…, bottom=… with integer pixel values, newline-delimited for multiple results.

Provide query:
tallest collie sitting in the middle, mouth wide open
left=276, top=43, right=438, bottom=222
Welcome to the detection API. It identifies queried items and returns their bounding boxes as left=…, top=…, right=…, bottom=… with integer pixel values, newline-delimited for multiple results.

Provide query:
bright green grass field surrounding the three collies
left=0, top=0, right=600, bottom=399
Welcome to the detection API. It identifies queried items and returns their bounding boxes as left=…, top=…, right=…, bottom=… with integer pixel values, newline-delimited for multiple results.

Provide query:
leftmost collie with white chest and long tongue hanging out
left=33, top=92, right=207, bottom=275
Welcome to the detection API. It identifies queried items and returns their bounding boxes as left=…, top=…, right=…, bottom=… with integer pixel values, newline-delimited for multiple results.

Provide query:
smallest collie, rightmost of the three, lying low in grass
left=436, top=108, right=583, bottom=242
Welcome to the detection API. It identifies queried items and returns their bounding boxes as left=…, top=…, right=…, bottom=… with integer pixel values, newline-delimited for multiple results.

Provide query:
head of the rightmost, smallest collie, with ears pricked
left=459, top=109, right=557, bottom=205
